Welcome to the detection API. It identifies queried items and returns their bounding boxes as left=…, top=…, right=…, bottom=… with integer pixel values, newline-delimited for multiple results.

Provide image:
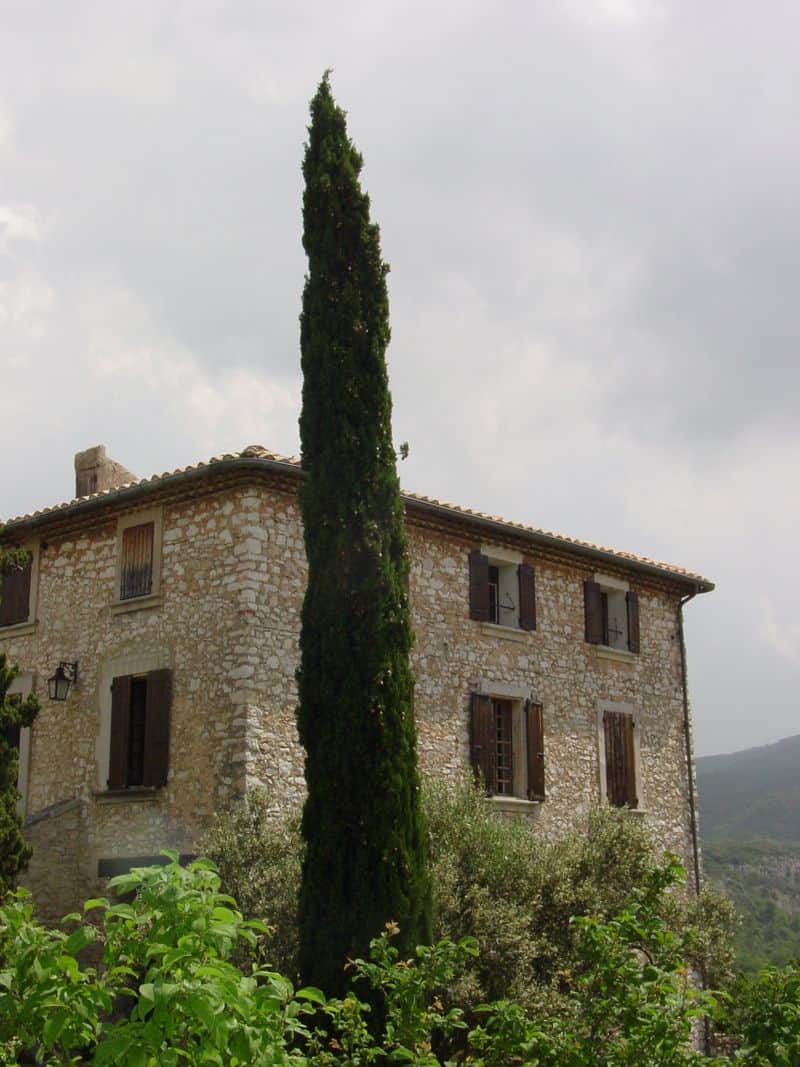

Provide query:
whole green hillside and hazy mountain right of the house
left=698, top=736, right=800, bottom=971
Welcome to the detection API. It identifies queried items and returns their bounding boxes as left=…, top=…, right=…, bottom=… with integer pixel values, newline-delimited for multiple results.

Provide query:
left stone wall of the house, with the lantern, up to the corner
left=0, top=490, right=267, bottom=910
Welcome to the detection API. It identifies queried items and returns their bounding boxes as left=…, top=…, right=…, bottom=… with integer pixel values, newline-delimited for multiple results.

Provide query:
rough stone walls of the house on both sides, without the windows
left=0, top=452, right=710, bottom=918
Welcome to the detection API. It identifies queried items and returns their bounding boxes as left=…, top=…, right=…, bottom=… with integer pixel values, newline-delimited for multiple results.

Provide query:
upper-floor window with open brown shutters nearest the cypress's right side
left=469, top=548, right=537, bottom=630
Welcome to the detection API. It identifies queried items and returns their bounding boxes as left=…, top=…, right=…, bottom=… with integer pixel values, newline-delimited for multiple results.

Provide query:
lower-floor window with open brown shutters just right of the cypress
left=469, top=692, right=545, bottom=800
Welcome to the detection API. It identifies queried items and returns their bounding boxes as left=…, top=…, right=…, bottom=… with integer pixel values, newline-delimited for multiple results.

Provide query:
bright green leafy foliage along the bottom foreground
left=0, top=854, right=759, bottom=1067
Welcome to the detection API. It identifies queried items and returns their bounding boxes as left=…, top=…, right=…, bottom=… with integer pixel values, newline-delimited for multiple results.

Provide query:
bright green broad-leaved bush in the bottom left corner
left=0, top=854, right=319, bottom=1067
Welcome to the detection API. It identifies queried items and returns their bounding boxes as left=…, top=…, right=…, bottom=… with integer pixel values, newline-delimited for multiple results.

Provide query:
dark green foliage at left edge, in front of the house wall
left=0, top=652, right=38, bottom=899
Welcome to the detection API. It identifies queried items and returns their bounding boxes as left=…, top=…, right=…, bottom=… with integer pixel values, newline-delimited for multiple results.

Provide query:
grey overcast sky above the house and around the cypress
left=0, top=0, right=800, bottom=754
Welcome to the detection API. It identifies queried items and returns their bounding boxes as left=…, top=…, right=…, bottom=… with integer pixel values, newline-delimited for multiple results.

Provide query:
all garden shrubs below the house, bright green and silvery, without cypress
left=0, top=785, right=800, bottom=1067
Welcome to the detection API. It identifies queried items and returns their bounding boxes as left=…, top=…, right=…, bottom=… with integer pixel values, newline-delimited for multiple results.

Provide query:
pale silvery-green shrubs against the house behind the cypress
left=202, top=780, right=736, bottom=1014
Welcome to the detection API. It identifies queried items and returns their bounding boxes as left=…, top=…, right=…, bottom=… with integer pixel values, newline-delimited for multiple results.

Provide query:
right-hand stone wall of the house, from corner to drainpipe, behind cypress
left=242, top=494, right=692, bottom=869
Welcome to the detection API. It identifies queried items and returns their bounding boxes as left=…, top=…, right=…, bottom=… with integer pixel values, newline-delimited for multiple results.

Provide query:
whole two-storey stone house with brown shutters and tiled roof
left=0, top=446, right=714, bottom=917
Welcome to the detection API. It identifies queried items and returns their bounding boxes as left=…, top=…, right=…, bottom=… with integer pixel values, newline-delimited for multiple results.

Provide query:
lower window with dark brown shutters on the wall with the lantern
left=108, top=670, right=172, bottom=790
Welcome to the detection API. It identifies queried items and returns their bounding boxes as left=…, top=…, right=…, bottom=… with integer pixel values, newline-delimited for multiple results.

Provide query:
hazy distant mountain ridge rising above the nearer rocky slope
left=698, top=735, right=800, bottom=843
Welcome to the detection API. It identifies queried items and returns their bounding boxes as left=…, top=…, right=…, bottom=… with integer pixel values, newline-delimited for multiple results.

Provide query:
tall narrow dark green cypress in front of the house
left=298, top=75, right=430, bottom=994
